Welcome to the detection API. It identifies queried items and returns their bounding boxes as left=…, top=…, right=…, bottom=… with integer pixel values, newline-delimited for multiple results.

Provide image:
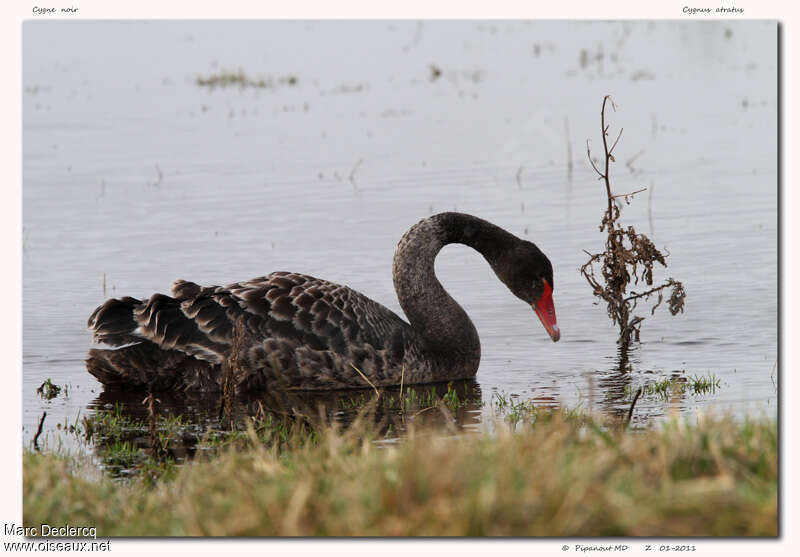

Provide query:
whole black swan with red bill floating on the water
left=86, top=213, right=560, bottom=392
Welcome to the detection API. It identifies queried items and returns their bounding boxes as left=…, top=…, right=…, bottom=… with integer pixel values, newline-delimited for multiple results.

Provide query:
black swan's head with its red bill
left=491, top=240, right=561, bottom=342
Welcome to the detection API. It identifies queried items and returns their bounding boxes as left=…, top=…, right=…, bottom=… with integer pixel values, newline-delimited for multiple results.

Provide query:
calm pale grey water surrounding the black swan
left=23, top=21, right=778, bottom=450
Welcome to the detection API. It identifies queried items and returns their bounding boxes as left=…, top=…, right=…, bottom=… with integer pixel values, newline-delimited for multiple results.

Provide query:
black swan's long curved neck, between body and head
left=392, top=213, right=513, bottom=373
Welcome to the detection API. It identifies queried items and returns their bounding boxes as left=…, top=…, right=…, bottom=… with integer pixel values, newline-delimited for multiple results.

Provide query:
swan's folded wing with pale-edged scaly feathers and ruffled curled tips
left=89, top=272, right=411, bottom=388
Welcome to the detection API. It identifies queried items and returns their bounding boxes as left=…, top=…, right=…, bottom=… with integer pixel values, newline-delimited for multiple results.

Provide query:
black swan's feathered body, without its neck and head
left=87, top=272, right=416, bottom=390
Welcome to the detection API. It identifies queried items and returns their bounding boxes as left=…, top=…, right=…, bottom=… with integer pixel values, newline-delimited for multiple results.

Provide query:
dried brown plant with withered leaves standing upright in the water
left=581, top=95, right=686, bottom=346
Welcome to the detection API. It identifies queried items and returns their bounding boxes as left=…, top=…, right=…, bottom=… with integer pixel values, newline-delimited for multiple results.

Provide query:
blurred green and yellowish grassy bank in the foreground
left=23, top=412, right=778, bottom=536
